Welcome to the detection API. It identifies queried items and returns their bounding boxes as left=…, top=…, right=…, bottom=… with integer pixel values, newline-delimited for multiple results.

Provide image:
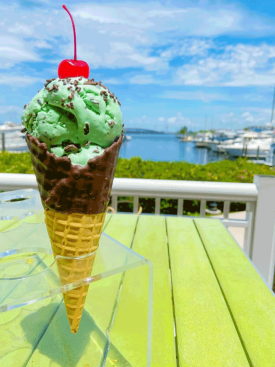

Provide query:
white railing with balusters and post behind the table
left=0, top=173, right=275, bottom=286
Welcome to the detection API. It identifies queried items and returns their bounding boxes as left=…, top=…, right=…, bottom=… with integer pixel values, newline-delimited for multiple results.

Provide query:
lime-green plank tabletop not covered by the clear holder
left=0, top=214, right=275, bottom=367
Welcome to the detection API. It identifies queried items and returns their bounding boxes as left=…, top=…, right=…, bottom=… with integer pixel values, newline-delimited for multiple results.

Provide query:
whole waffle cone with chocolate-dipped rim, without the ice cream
left=26, top=134, right=123, bottom=333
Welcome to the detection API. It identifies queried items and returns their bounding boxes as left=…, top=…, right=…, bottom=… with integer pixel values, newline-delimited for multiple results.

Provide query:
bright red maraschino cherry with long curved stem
left=57, top=5, right=90, bottom=79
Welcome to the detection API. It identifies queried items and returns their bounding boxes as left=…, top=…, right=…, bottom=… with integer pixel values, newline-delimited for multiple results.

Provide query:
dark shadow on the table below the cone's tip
left=21, top=302, right=106, bottom=367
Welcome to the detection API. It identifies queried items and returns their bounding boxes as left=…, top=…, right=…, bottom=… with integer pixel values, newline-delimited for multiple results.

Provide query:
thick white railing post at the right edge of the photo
left=251, top=175, right=275, bottom=288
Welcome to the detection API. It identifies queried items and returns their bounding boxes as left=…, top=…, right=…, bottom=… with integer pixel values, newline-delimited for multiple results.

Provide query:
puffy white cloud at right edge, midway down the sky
left=175, top=44, right=275, bottom=86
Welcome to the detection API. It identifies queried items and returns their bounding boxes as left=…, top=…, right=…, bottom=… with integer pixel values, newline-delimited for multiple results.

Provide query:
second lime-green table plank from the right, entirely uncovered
left=167, top=218, right=249, bottom=367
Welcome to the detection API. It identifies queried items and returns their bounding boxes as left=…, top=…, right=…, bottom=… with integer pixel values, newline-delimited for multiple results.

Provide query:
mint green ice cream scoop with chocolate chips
left=22, top=77, right=122, bottom=166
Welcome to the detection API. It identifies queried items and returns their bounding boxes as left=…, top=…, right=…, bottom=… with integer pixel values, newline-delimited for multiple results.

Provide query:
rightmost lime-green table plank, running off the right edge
left=195, top=219, right=275, bottom=367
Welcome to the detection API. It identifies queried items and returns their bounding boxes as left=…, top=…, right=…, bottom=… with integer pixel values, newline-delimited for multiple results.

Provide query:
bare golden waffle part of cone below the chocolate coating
left=45, top=210, right=105, bottom=333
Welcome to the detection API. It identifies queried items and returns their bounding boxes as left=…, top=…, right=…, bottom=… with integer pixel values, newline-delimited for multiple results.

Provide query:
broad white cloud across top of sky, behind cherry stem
left=0, top=1, right=275, bottom=73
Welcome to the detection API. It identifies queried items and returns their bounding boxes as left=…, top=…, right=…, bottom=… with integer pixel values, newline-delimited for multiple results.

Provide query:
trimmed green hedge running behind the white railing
left=0, top=152, right=275, bottom=215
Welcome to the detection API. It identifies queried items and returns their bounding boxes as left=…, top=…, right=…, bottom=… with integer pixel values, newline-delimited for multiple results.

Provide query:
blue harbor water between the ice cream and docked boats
left=119, top=134, right=229, bottom=164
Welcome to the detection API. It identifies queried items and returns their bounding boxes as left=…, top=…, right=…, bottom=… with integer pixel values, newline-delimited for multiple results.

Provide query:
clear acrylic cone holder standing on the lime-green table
left=0, top=190, right=153, bottom=367
